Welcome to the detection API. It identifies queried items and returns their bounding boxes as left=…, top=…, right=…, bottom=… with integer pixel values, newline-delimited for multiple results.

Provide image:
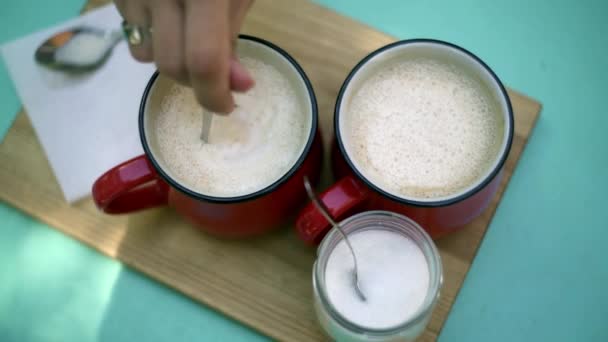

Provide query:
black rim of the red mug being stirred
left=139, top=34, right=318, bottom=203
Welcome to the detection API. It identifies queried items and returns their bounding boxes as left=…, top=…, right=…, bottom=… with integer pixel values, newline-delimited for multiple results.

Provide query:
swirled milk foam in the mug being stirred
left=155, top=57, right=310, bottom=197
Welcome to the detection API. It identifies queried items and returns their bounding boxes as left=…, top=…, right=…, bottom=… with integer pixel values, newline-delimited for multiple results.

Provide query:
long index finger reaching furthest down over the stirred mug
left=185, top=0, right=234, bottom=113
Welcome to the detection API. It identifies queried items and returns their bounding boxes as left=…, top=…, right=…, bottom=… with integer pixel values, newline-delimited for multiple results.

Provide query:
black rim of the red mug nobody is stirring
left=334, top=38, right=515, bottom=208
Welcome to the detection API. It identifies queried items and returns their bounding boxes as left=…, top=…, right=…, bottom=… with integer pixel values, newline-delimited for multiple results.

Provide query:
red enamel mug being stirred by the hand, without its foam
left=92, top=35, right=322, bottom=237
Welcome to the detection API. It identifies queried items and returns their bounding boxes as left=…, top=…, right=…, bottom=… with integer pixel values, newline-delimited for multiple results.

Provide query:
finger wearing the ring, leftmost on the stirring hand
left=117, top=0, right=154, bottom=62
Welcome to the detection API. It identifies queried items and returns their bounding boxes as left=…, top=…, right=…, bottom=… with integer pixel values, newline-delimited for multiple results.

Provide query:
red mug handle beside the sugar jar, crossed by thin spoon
left=296, top=176, right=369, bottom=245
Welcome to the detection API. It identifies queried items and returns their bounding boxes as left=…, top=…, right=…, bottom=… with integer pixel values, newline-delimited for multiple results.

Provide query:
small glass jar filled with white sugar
left=313, top=211, right=443, bottom=341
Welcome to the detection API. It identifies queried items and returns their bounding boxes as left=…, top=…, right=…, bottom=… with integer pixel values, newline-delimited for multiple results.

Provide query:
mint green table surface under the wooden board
left=0, top=0, right=608, bottom=342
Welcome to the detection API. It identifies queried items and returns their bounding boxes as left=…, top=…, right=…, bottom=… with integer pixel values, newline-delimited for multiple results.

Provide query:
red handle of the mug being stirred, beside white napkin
left=92, top=154, right=169, bottom=214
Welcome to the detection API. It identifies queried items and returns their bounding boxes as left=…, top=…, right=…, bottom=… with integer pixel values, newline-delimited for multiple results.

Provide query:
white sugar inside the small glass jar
left=325, top=229, right=430, bottom=329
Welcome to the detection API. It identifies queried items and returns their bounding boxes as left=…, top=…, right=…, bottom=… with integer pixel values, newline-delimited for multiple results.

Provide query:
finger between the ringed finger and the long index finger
left=151, top=0, right=188, bottom=83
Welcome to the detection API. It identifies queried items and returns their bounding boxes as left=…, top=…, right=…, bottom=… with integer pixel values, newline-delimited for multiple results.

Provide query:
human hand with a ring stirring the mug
left=115, top=0, right=254, bottom=113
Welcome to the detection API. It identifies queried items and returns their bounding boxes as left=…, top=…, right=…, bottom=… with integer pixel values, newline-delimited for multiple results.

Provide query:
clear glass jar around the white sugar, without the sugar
left=312, top=211, right=443, bottom=341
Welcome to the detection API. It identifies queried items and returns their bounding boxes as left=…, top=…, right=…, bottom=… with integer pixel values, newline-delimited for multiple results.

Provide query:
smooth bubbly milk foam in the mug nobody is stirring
left=341, top=59, right=504, bottom=200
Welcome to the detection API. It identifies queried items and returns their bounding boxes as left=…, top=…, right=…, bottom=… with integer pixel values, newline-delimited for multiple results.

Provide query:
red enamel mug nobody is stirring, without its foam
left=296, top=39, right=514, bottom=244
